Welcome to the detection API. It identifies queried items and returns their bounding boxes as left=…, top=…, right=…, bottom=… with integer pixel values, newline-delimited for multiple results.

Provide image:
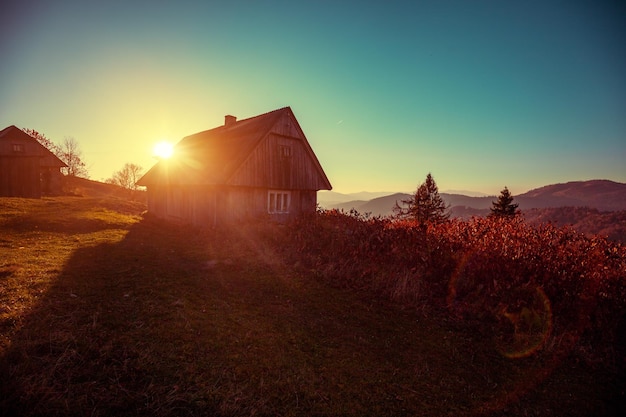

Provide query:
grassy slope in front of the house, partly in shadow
left=0, top=197, right=623, bottom=416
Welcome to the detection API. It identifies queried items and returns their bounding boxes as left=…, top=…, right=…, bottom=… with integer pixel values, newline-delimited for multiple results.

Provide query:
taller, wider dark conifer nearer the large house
left=394, top=173, right=450, bottom=223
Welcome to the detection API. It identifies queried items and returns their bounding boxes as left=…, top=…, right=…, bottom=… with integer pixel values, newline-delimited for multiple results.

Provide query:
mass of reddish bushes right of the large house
left=272, top=210, right=626, bottom=368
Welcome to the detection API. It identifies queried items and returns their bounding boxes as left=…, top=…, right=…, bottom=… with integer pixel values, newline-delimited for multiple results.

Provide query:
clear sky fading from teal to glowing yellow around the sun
left=0, top=0, right=626, bottom=194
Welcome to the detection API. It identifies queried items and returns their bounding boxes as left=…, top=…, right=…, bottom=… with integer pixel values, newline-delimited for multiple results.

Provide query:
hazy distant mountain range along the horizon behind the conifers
left=318, top=180, right=626, bottom=218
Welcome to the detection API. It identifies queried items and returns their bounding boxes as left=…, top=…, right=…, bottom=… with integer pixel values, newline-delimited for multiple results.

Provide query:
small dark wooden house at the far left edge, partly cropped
left=0, top=126, right=67, bottom=198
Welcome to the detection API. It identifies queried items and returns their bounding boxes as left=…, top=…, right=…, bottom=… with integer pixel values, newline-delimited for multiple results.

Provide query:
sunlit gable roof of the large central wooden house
left=137, top=107, right=331, bottom=189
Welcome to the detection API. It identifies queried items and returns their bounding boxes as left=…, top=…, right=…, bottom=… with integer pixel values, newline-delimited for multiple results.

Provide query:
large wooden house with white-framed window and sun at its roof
left=138, top=107, right=332, bottom=226
